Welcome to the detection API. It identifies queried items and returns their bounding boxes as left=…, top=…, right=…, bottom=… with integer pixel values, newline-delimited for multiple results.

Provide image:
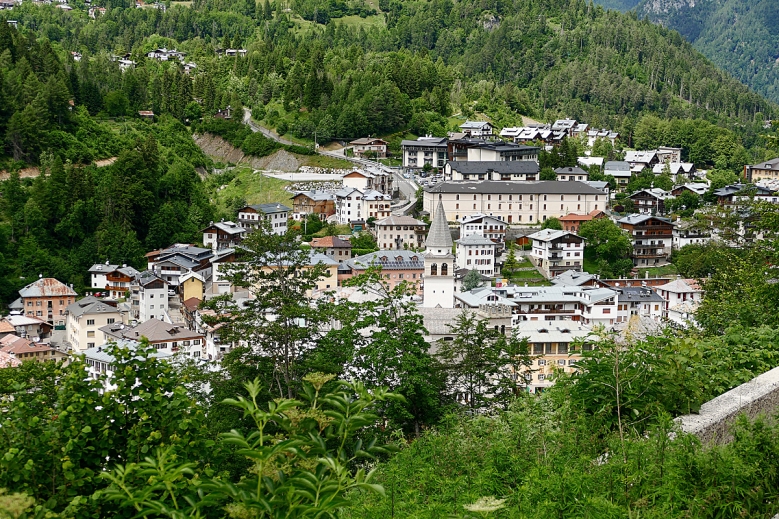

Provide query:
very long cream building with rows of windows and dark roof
left=424, top=180, right=607, bottom=224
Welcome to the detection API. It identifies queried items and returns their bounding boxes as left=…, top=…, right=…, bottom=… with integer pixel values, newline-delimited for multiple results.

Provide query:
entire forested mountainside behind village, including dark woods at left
left=0, top=0, right=777, bottom=304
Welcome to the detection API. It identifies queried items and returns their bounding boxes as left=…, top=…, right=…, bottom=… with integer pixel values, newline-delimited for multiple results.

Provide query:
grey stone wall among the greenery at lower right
left=676, top=368, right=779, bottom=444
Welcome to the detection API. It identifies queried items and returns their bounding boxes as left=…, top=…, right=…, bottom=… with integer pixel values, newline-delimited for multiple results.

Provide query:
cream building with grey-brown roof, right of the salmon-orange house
left=65, top=296, right=122, bottom=353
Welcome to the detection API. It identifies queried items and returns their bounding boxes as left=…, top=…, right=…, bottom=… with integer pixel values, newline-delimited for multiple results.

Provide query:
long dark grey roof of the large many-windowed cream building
left=427, top=180, right=605, bottom=195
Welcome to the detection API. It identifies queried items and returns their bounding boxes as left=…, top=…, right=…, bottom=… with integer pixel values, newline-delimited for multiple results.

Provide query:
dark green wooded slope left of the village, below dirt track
left=0, top=117, right=213, bottom=304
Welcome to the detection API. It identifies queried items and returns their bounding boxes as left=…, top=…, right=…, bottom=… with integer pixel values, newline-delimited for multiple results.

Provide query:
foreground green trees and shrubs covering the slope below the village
left=0, top=221, right=779, bottom=519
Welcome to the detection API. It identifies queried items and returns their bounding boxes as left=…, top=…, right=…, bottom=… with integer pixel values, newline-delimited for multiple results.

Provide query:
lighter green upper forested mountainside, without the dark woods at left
left=0, top=0, right=777, bottom=157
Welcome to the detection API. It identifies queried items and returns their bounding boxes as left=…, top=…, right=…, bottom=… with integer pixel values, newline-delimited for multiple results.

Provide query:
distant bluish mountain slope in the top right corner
left=637, top=0, right=779, bottom=102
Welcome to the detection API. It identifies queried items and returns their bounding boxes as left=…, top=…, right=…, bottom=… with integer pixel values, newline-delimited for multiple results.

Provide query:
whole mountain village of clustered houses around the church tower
left=0, top=119, right=779, bottom=392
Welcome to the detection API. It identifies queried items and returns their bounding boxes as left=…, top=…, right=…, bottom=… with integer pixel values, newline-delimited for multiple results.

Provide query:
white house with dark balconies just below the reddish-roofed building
left=528, top=229, right=584, bottom=279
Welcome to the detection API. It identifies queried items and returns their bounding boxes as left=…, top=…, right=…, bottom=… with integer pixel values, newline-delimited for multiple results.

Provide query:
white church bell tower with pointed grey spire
left=423, top=198, right=455, bottom=308
